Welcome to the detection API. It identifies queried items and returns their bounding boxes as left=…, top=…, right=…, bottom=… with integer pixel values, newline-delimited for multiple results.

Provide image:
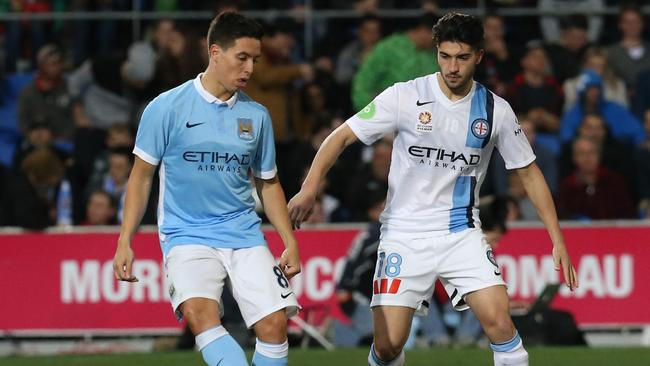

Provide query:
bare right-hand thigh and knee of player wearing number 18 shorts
left=465, top=285, right=515, bottom=343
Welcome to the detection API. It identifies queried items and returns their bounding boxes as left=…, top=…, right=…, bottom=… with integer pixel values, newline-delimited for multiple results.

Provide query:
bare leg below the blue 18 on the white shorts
left=368, top=306, right=415, bottom=366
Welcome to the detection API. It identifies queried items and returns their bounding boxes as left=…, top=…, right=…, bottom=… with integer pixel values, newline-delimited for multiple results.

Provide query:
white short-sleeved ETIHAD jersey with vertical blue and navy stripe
left=346, top=73, right=535, bottom=234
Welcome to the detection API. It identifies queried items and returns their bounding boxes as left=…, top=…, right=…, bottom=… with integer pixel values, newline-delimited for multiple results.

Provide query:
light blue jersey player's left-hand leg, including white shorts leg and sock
left=165, top=245, right=248, bottom=366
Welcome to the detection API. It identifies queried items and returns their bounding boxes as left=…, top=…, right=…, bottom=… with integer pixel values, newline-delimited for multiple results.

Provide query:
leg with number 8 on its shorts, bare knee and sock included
left=227, top=246, right=299, bottom=366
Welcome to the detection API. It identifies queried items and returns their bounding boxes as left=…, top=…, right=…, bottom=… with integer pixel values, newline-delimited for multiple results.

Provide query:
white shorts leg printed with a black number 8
left=228, top=246, right=300, bottom=328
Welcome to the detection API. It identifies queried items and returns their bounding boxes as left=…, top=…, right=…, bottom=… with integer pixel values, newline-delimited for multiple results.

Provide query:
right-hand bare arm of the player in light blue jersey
left=255, top=177, right=300, bottom=278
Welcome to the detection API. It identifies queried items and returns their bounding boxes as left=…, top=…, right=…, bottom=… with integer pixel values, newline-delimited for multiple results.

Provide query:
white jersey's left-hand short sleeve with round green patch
left=345, top=85, right=399, bottom=145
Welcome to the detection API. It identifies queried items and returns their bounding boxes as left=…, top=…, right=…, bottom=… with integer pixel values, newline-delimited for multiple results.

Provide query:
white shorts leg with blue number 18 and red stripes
left=370, top=235, right=436, bottom=315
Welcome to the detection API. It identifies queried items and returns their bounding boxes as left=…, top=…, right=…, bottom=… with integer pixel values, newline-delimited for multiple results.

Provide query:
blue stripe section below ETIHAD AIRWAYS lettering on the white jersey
left=449, top=176, right=476, bottom=233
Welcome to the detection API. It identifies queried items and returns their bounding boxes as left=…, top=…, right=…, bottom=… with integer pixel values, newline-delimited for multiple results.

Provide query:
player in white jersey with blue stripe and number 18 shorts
left=289, top=13, right=578, bottom=366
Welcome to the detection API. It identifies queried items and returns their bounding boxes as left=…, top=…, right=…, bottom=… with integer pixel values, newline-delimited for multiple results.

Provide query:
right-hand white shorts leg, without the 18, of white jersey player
left=438, top=229, right=505, bottom=310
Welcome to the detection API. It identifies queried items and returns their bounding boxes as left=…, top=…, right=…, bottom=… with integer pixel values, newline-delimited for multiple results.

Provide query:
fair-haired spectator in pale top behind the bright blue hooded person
left=562, top=47, right=629, bottom=112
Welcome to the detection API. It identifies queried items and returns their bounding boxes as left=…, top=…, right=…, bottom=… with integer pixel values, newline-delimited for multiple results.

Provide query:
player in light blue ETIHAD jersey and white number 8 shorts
left=113, top=13, right=300, bottom=366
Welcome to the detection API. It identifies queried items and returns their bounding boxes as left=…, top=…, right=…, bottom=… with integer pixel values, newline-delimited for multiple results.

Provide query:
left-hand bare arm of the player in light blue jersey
left=113, top=156, right=156, bottom=282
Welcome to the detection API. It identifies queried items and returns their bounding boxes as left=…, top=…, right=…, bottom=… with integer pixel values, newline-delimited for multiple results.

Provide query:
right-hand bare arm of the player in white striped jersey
left=517, top=162, right=578, bottom=290
